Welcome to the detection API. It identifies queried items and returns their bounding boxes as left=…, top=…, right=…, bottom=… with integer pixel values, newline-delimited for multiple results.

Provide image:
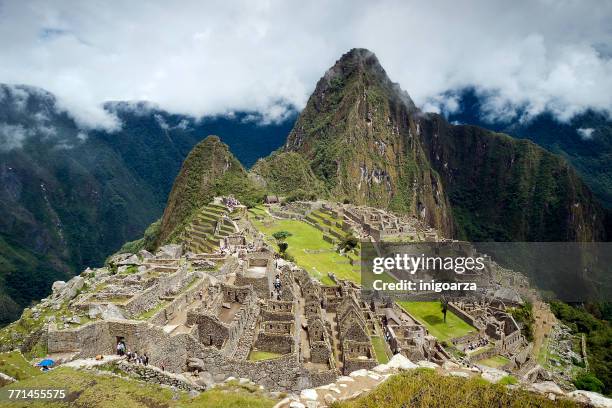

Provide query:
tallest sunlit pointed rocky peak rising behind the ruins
left=284, top=49, right=454, bottom=235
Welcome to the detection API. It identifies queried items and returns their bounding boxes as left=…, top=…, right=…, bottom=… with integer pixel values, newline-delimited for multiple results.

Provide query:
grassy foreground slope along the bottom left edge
left=0, top=367, right=278, bottom=408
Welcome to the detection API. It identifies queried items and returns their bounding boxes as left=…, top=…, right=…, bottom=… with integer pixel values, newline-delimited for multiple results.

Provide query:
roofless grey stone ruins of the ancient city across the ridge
left=39, top=199, right=536, bottom=391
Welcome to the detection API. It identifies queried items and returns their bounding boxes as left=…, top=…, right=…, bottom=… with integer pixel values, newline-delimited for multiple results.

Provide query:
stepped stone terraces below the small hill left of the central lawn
left=181, top=204, right=235, bottom=253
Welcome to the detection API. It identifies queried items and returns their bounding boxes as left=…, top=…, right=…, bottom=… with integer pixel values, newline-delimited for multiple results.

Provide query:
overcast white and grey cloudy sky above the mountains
left=0, top=0, right=612, bottom=128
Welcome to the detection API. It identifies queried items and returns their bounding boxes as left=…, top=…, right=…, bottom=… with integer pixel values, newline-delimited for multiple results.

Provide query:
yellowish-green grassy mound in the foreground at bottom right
left=331, top=369, right=580, bottom=408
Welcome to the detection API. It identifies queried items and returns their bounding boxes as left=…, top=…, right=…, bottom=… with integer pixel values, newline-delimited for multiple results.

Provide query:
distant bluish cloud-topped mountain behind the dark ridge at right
left=448, top=88, right=612, bottom=208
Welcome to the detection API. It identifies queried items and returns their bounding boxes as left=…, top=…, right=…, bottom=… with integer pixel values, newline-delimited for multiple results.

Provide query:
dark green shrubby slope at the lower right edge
left=550, top=302, right=612, bottom=395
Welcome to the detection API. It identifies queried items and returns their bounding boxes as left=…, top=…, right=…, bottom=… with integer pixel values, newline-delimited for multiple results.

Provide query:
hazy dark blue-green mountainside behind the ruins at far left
left=0, top=85, right=292, bottom=325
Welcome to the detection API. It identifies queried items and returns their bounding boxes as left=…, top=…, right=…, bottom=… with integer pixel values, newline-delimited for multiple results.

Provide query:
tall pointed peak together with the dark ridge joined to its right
left=284, top=49, right=607, bottom=241
